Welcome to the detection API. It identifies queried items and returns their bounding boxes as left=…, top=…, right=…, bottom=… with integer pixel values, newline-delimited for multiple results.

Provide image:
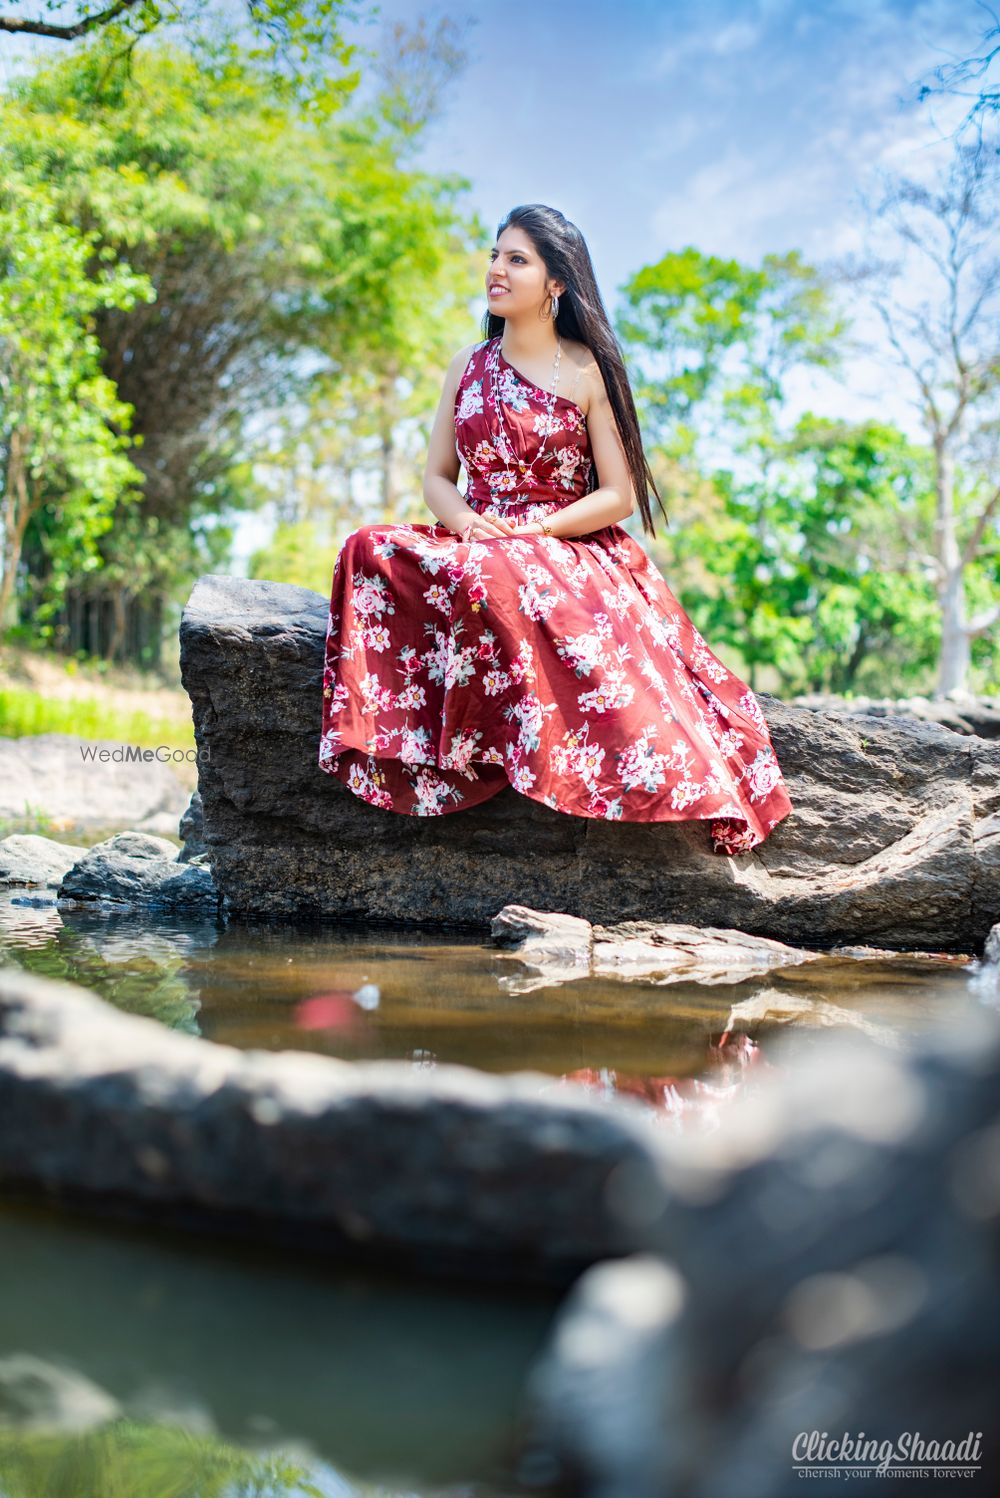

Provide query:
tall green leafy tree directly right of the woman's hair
left=618, top=246, right=846, bottom=686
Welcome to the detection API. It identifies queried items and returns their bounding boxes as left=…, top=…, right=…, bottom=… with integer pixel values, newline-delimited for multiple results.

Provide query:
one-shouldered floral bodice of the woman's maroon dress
left=455, top=334, right=593, bottom=505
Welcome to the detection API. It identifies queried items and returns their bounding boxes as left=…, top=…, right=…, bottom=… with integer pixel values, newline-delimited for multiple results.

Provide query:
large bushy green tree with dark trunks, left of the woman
left=1, top=20, right=482, bottom=656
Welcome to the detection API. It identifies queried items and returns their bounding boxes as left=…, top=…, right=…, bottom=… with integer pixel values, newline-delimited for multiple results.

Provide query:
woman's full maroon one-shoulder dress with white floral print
left=319, top=337, right=792, bottom=854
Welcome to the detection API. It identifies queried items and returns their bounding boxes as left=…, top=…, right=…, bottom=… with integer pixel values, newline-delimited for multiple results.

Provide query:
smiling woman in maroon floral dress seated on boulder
left=319, top=204, right=792, bottom=854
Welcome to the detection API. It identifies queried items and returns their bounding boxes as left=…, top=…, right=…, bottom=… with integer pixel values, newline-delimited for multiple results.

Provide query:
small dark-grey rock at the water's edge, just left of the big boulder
left=58, top=833, right=219, bottom=911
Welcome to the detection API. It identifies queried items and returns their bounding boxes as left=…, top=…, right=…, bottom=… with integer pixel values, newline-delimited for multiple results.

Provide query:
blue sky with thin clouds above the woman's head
left=350, top=0, right=990, bottom=303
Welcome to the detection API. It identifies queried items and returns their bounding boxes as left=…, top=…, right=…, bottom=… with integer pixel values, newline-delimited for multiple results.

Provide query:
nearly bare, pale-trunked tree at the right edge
left=841, top=136, right=1000, bottom=695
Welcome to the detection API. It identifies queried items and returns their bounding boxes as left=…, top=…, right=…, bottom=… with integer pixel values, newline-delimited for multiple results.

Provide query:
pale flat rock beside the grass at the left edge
left=0, top=734, right=187, bottom=831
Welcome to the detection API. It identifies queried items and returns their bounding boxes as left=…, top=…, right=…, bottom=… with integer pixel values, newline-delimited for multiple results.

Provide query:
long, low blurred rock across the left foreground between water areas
left=0, top=968, right=656, bottom=1281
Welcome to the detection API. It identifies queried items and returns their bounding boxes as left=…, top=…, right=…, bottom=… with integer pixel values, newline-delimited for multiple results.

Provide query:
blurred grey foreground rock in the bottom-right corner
left=523, top=998, right=1000, bottom=1498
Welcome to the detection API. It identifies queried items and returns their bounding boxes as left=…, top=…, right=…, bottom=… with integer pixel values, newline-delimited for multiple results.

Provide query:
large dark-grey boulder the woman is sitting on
left=181, top=577, right=1000, bottom=951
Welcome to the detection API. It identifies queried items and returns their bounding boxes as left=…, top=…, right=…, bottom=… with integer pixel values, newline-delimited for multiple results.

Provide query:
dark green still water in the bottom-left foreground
left=0, top=1203, right=555, bottom=1498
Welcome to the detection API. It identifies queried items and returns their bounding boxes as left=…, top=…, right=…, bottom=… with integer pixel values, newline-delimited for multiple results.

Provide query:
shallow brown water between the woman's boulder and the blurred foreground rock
left=0, top=896, right=982, bottom=1121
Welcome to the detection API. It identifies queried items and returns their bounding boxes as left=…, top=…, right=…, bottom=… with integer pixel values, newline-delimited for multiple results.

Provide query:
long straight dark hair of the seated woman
left=482, top=202, right=671, bottom=536
